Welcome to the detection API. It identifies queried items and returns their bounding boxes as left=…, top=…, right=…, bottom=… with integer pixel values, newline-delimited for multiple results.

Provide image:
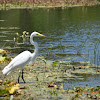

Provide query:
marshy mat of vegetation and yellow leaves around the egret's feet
left=0, top=56, right=100, bottom=100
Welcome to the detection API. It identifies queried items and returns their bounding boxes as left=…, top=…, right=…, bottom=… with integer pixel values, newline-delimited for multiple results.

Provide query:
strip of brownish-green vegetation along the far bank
left=0, top=0, right=100, bottom=8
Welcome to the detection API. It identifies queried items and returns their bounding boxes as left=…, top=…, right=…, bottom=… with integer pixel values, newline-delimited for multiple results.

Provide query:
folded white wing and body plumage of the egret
left=2, top=51, right=31, bottom=74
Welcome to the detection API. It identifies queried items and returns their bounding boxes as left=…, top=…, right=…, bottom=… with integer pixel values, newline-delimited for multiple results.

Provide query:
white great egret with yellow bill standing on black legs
left=2, top=32, right=46, bottom=83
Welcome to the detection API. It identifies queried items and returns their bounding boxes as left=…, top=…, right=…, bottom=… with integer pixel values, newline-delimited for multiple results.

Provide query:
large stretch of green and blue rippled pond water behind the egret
left=0, top=6, right=100, bottom=87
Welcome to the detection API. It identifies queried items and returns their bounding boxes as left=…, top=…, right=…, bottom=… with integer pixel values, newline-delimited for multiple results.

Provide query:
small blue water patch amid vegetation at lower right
left=64, top=74, right=100, bottom=89
